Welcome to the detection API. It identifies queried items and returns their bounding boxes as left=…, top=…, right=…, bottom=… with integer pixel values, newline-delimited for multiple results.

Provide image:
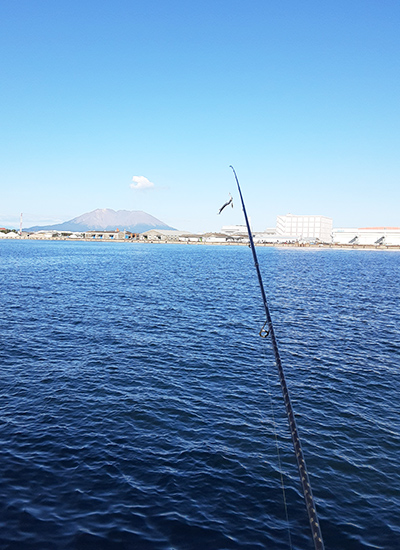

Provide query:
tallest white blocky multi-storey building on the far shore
left=276, top=214, right=333, bottom=243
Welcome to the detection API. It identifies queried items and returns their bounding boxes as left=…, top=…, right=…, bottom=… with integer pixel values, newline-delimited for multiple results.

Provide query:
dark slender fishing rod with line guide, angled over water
left=230, top=166, right=324, bottom=550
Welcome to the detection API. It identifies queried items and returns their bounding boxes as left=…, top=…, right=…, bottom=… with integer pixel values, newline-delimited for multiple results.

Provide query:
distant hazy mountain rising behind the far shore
left=24, top=208, right=173, bottom=233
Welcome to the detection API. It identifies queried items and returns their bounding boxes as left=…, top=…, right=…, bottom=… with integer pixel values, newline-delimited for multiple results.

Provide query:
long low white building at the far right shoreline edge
left=332, top=227, right=400, bottom=246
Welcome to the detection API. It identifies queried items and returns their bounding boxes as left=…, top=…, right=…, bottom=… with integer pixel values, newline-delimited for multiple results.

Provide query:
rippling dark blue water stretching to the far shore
left=0, top=241, right=400, bottom=550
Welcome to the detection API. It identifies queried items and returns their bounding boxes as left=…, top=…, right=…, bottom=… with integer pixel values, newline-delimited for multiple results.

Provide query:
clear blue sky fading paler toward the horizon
left=0, top=0, right=400, bottom=231
